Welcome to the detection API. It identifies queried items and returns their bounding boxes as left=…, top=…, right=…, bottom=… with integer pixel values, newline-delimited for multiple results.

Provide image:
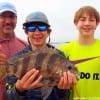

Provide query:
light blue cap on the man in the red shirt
left=0, top=2, right=17, bottom=15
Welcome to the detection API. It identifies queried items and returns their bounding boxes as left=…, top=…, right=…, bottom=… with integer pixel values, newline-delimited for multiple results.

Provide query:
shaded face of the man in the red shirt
left=0, top=11, right=17, bottom=37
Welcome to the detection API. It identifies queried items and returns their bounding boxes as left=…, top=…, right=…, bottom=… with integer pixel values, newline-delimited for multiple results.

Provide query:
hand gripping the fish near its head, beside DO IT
left=58, top=71, right=77, bottom=89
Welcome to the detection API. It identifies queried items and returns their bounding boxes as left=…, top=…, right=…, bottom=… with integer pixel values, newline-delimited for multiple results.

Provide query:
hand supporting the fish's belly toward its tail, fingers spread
left=15, top=69, right=42, bottom=92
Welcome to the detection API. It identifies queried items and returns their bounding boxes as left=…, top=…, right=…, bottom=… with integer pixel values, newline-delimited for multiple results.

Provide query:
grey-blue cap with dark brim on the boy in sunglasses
left=23, top=11, right=50, bottom=26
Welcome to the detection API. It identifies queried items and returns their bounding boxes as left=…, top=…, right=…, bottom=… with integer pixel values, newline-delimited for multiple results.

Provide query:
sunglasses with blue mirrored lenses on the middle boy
left=25, top=25, right=48, bottom=32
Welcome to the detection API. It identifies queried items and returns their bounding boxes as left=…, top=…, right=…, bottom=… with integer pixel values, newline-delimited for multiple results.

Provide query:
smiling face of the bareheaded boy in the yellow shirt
left=75, top=14, right=98, bottom=36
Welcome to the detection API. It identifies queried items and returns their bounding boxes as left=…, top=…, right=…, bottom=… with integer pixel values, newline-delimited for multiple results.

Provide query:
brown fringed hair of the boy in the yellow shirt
left=74, top=6, right=100, bottom=23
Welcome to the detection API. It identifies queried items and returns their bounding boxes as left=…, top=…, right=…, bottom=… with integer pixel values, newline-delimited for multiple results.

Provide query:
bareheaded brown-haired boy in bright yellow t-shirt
left=60, top=6, right=100, bottom=100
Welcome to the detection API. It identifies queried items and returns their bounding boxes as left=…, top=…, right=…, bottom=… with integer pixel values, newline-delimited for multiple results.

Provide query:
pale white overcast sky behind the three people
left=0, top=0, right=100, bottom=43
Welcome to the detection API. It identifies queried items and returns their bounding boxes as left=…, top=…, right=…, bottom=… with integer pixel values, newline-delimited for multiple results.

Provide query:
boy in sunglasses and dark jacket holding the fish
left=7, top=12, right=77, bottom=100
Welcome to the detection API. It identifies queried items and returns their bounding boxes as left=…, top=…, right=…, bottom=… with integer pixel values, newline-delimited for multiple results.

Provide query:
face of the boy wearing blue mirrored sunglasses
left=26, top=23, right=50, bottom=48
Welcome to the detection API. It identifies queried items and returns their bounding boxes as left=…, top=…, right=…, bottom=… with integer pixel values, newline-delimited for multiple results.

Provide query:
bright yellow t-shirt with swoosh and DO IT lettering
left=60, top=40, right=100, bottom=100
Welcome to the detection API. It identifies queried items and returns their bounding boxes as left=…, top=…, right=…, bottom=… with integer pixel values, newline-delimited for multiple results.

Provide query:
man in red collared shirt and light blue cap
left=0, top=2, right=26, bottom=100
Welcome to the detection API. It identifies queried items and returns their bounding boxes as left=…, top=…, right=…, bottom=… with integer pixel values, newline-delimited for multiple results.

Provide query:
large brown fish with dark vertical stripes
left=0, top=47, right=79, bottom=87
